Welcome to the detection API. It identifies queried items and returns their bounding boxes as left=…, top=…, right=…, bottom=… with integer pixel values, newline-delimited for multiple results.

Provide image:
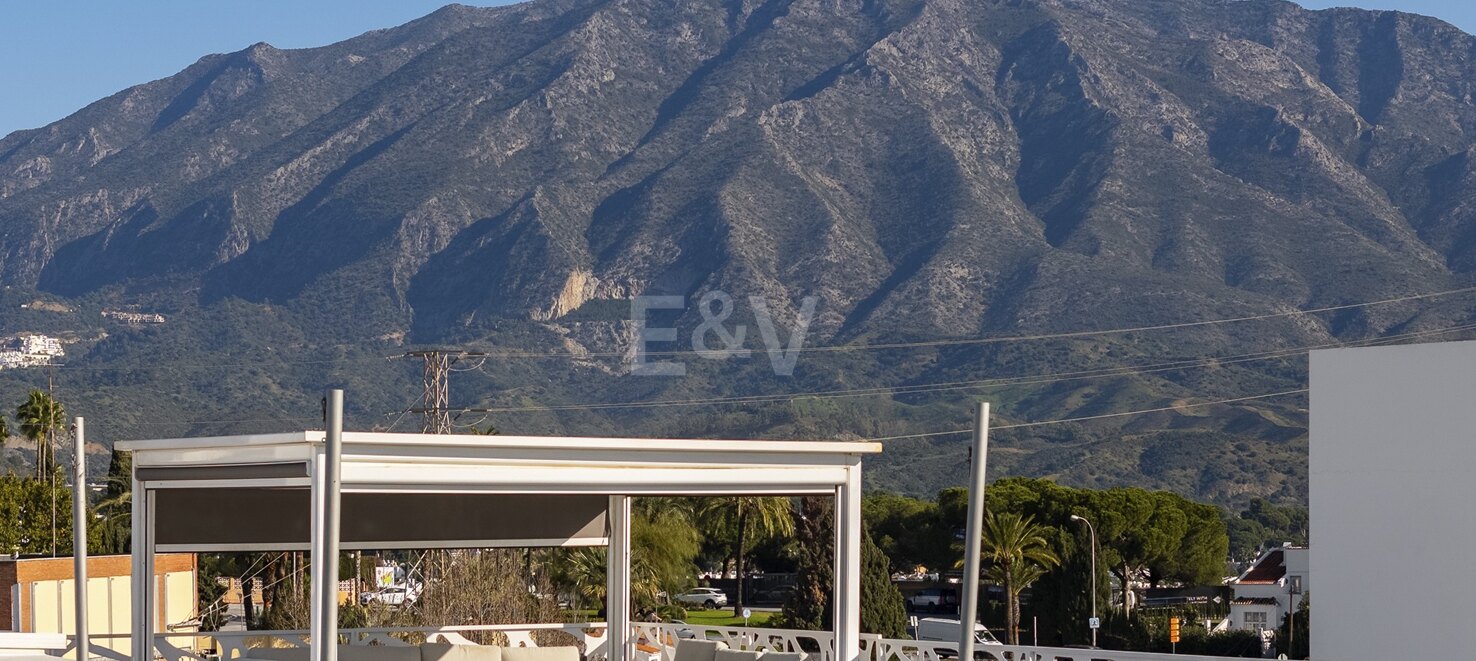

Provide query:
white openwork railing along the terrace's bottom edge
left=49, top=623, right=1245, bottom=661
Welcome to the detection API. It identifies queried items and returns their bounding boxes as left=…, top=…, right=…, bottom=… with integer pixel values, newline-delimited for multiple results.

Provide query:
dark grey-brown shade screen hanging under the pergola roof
left=151, top=487, right=610, bottom=550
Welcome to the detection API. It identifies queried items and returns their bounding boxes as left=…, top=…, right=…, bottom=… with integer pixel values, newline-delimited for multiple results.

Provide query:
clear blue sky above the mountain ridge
left=0, top=0, right=1476, bottom=136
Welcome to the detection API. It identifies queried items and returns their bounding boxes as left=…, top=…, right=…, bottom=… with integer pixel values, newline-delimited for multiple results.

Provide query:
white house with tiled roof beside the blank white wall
left=1230, top=546, right=1308, bottom=631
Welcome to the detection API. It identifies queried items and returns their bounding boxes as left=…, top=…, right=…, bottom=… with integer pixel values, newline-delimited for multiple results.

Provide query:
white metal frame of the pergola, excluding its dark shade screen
left=117, top=429, right=881, bottom=661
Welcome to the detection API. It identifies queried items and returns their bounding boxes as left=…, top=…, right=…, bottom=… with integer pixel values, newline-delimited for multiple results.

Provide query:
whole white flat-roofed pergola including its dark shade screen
left=118, top=429, right=881, bottom=661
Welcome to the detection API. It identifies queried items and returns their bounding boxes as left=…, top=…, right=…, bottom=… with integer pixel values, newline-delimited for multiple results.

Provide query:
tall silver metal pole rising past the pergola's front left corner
left=311, top=390, right=344, bottom=661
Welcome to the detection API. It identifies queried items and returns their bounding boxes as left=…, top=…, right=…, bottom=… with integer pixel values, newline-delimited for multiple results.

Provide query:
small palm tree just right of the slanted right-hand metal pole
left=959, top=512, right=1061, bottom=645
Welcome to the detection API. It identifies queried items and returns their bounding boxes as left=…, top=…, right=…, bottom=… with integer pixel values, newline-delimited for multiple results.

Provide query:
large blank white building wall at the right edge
left=1309, top=342, right=1476, bottom=660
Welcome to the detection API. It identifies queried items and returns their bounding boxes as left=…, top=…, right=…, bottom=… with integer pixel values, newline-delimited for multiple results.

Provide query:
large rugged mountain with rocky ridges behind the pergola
left=0, top=0, right=1476, bottom=503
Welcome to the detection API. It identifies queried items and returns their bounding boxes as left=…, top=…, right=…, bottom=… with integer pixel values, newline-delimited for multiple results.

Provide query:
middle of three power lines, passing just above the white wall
left=428, top=323, right=1476, bottom=413
